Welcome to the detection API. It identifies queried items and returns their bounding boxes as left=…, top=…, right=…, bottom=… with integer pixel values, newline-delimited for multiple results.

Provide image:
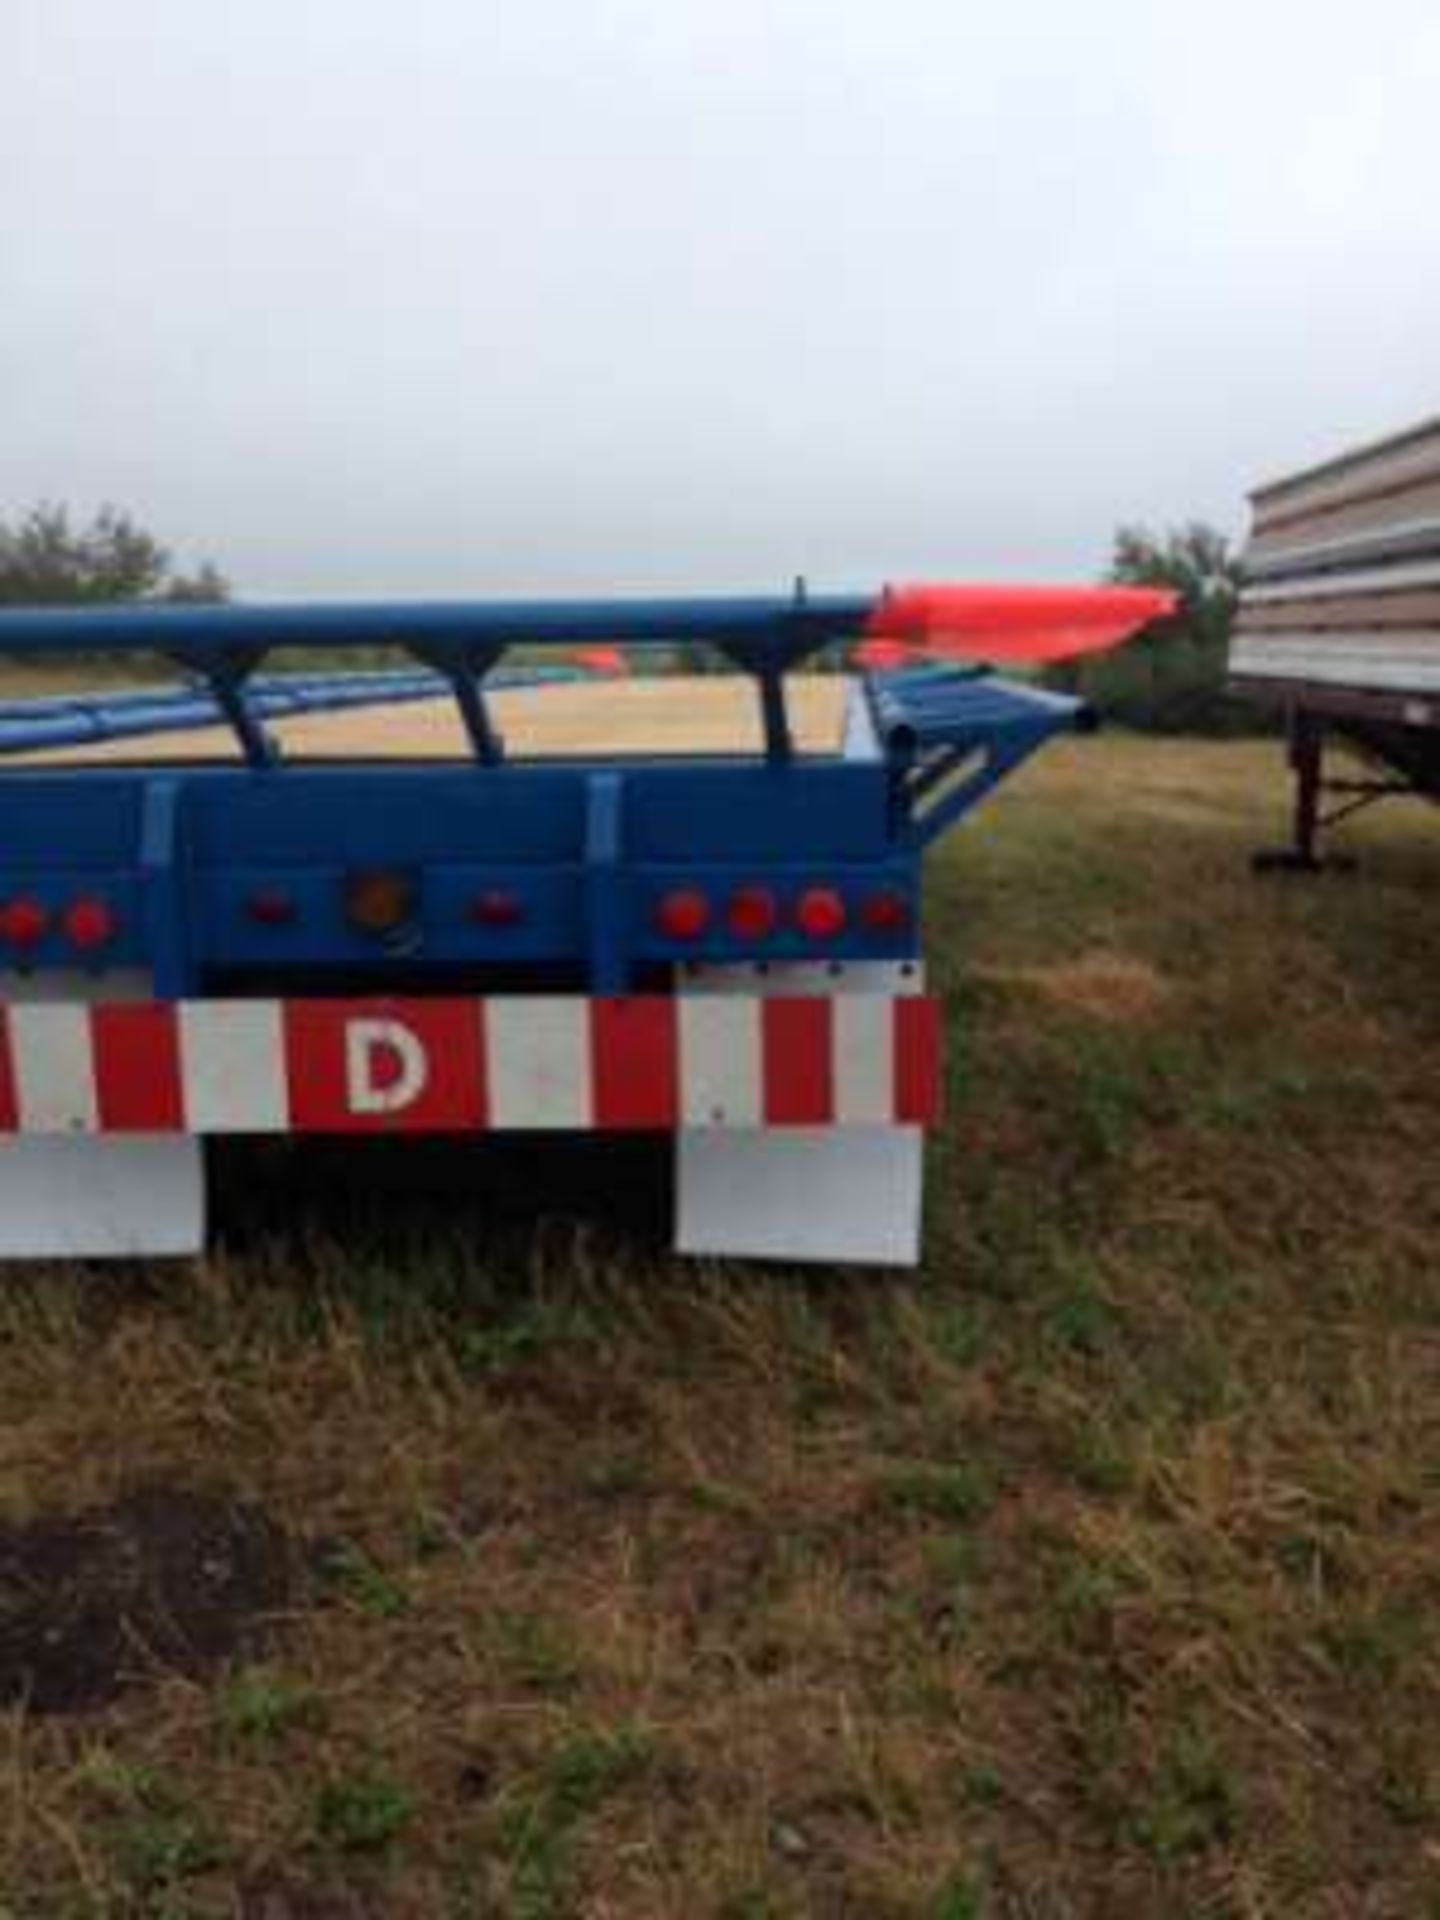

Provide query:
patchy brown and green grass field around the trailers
left=0, top=739, right=1440, bottom=1920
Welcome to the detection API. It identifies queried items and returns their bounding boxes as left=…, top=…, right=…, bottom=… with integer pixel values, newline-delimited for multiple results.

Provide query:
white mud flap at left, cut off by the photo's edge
left=0, top=972, right=205, bottom=1260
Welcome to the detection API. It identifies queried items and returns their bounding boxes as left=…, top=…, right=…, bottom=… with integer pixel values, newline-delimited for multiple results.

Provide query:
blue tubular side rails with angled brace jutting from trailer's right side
left=866, top=666, right=1096, bottom=847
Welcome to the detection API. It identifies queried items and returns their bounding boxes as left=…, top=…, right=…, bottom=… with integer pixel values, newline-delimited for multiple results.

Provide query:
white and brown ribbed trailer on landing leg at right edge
left=1231, top=420, right=1440, bottom=870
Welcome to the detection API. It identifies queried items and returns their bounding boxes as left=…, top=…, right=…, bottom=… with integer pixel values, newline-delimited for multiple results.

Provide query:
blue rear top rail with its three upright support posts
left=0, top=588, right=877, bottom=766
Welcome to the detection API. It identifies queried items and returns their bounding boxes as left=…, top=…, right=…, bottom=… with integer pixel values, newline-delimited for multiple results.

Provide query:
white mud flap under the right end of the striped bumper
left=676, top=962, right=925, bottom=1267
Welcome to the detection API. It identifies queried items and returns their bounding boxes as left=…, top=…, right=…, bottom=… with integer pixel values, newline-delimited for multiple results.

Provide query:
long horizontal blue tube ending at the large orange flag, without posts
left=0, top=593, right=877, bottom=664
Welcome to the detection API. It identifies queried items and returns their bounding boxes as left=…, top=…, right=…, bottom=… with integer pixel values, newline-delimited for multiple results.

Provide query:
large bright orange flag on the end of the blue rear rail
left=866, top=586, right=1179, bottom=662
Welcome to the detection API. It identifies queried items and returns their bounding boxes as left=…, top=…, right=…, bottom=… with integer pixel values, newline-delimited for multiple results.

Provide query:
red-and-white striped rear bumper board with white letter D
left=0, top=993, right=941, bottom=1137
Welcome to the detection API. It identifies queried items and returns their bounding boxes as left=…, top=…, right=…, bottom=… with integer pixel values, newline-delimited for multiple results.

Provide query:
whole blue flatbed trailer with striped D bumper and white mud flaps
left=0, top=595, right=1113, bottom=1261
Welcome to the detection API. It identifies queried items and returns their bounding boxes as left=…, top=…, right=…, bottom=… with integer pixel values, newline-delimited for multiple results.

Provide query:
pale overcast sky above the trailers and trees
left=0, top=0, right=1440, bottom=595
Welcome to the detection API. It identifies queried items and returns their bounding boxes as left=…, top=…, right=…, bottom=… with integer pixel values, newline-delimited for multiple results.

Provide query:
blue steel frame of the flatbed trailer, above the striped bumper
left=0, top=599, right=1085, bottom=998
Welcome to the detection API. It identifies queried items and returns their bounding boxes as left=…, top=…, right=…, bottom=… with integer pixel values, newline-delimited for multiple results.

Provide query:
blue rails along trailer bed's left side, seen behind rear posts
left=0, top=666, right=584, bottom=756
